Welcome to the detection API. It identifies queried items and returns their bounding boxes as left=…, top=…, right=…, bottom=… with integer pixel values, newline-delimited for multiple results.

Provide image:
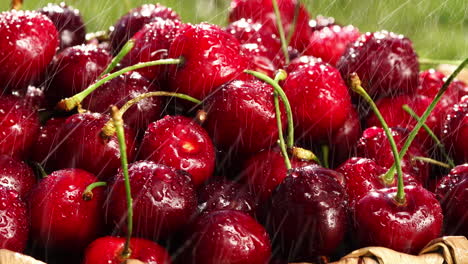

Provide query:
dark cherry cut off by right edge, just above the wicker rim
left=435, top=164, right=468, bottom=236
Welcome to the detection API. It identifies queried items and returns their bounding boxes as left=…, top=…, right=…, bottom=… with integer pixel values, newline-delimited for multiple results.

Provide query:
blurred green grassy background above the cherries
left=0, top=0, right=468, bottom=59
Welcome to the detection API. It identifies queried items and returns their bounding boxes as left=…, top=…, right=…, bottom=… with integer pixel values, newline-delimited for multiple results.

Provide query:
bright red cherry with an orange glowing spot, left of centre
left=139, top=116, right=215, bottom=186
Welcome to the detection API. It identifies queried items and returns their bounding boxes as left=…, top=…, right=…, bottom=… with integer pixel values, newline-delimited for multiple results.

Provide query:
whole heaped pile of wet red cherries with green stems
left=0, top=0, right=468, bottom=264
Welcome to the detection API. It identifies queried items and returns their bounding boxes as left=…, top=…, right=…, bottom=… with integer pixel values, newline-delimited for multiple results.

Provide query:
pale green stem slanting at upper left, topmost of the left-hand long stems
left=57, top=58, right=183, bottom=111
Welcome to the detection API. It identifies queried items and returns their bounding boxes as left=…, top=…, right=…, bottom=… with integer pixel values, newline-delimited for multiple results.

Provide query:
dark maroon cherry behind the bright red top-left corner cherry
left=38, top=2, right=86, bottom=49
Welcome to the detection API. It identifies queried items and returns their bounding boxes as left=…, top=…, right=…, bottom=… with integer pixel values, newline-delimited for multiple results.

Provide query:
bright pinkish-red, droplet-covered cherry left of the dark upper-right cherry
left=304, top=25, right=361, bottom=65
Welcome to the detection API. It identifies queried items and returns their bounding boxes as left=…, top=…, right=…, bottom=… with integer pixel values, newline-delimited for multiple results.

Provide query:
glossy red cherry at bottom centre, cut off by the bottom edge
left=186, top=210, right=271, bottom=264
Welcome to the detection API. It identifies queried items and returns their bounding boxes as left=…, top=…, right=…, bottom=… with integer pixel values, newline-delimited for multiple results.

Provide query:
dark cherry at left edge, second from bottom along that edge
left=0, top=155, right=36, bottom=199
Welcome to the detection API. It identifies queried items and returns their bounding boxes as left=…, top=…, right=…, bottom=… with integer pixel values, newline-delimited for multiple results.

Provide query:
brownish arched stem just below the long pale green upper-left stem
left=102, top=91, right=201, bottom=137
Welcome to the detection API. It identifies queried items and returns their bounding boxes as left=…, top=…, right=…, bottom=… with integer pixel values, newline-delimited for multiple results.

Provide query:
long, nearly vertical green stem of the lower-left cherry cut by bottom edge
left=111, top=106, right=133, bottom=258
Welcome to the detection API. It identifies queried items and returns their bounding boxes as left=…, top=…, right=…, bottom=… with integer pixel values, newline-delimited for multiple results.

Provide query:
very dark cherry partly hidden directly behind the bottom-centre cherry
left=198, top=180, right=257, bottom=216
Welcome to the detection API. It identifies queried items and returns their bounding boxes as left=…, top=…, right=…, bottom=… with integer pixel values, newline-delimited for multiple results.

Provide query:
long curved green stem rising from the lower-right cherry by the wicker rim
left=351, top=73, right=405, bottom=201
